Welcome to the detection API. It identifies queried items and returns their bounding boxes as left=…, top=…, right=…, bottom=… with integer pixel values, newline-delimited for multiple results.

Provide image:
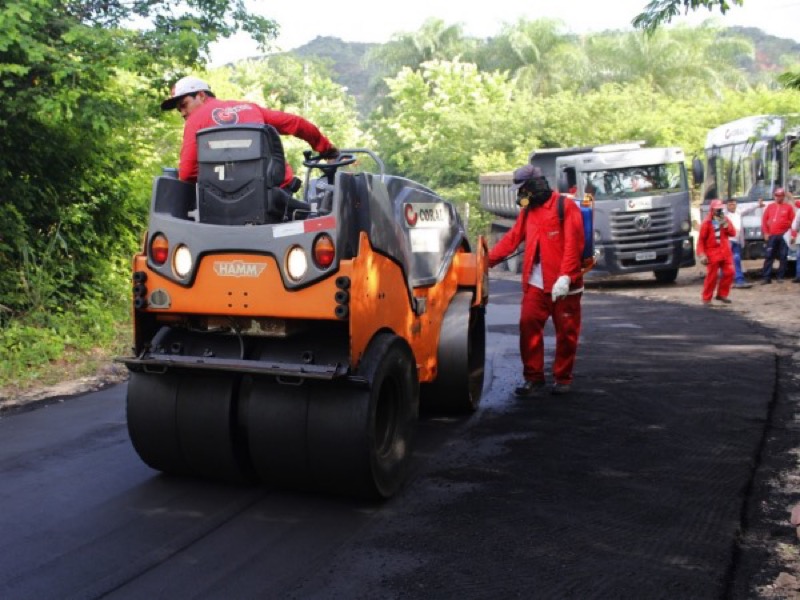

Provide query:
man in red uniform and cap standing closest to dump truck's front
left=697, top=200, right=736, bottom=306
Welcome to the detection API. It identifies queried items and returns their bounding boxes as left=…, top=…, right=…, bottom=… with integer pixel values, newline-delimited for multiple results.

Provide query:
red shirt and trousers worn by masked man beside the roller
left=489, top=192, right=584, bottom=384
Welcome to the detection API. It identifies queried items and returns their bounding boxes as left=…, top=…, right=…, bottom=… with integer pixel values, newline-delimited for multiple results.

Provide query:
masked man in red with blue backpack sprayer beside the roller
left=489, top=165, right=584, bottom=397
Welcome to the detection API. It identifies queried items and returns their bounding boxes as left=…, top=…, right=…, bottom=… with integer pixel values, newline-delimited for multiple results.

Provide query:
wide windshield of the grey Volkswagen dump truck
left=585, top=163, right=688, bottom=202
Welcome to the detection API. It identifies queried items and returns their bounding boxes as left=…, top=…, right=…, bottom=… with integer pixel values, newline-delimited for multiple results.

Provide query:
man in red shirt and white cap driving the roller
left=161, top=77, right=338, bottom=191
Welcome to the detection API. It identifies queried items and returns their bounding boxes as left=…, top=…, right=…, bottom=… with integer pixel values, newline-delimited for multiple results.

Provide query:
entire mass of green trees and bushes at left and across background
left=0, top=0, right=800, bottom=388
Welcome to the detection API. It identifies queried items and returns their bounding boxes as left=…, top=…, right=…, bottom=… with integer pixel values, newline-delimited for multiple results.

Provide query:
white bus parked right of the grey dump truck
left=692, top=115, right=800, bottom=259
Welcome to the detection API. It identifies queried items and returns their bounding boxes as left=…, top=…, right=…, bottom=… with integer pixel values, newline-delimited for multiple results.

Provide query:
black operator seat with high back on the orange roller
left=197, top=124, right=308, bottom=225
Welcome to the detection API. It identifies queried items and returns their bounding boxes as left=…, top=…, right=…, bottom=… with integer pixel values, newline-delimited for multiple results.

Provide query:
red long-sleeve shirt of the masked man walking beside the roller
left=489, top=192, right=584, bottom=293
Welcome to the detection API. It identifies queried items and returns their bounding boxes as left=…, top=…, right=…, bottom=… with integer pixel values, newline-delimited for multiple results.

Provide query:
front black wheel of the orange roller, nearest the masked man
left=421, top=291, right=486, bottom=415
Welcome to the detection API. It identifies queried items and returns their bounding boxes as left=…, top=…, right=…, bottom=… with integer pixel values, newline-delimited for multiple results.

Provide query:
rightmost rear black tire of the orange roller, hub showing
left=308, top=333, right=419, bottom=499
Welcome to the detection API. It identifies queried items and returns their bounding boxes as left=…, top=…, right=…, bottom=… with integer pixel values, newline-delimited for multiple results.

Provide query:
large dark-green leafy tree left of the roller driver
left=0, top=0, right=275, bottom=311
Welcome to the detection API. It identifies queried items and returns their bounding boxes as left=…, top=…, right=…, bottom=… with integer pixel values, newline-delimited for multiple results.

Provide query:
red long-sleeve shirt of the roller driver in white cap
left=178, top=97, right=331, bottom=186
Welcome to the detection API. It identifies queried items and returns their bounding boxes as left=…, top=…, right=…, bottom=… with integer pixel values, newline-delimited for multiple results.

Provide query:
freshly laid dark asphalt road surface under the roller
left=0, top=280, right=783, bottom=600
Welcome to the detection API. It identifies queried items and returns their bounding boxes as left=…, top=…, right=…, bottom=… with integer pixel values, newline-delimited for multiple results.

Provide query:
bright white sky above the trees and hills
left=211, top=0, right=800, bottom=66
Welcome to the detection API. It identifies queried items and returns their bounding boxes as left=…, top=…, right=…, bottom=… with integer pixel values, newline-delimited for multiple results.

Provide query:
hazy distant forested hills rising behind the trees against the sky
left=287, top=27, right=800, bottom=114
